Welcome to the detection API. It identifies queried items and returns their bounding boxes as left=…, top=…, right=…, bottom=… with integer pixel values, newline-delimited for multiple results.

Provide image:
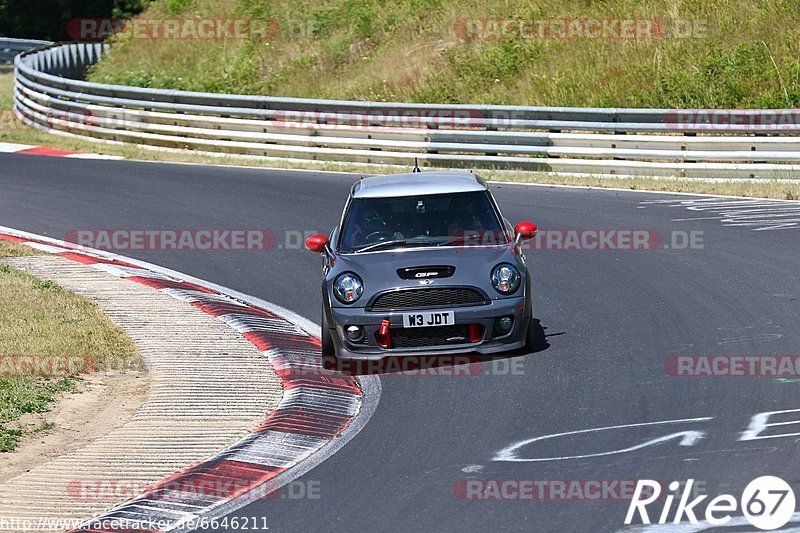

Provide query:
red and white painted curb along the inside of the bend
left=0, top=226, right=381, bottom=532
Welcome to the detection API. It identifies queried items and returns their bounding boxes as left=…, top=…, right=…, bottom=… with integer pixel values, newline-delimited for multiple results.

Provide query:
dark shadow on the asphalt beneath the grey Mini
left=322, top=318, right=552, bottom=376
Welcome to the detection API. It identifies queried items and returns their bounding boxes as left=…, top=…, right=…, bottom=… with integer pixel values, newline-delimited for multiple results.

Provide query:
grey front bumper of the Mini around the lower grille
left=328, top=296, right=530, bottom=360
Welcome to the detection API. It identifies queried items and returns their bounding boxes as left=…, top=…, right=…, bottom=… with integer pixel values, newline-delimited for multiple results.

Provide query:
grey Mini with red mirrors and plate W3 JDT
left=306, top=172, right=536, bottom=359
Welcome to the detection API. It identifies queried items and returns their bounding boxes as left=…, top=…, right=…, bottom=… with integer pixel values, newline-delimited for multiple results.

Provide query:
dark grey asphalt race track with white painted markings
left=0, top=155, right=800, bottom=532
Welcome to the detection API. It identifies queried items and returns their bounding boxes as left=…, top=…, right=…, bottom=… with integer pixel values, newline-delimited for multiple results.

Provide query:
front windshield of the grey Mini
left=339, top=191, right=507, bottom=253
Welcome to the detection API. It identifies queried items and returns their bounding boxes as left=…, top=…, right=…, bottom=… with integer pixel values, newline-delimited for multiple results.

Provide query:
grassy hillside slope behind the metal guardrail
left=91, top=0, right=800, bottom=109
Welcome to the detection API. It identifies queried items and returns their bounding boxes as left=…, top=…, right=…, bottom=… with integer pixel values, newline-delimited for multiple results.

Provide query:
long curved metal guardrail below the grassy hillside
left=14, top=43, right=800, bottom=179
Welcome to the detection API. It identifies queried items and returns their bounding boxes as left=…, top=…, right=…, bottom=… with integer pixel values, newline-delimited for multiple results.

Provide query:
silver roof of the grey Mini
left=352, top=172, right=488, bottom=198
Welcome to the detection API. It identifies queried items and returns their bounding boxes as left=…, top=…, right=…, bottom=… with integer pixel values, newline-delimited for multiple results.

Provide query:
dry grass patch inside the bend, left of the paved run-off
left=0, top=241, right=142, bottom=452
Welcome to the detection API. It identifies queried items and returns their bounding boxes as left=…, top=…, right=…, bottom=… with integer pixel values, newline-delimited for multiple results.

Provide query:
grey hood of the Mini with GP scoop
left=327, top=244, right=525, bottom=307
